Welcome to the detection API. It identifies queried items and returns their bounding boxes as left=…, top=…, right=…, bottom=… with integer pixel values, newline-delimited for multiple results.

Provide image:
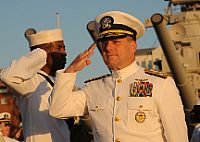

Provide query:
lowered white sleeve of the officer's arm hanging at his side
left=158, top=78, right=188, bottom=142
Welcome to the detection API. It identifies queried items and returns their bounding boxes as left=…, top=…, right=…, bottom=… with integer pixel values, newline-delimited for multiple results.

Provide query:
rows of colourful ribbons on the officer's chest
left=130, top=79, right=153, bottom=97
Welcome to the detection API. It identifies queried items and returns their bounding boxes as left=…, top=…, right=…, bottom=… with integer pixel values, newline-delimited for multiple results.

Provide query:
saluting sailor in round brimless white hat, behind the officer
left=0, top=29, right=70, bottom=142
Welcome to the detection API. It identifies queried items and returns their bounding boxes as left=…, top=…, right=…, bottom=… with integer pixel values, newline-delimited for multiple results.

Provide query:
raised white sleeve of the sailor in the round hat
left=0, top=48, right=47, bottom=95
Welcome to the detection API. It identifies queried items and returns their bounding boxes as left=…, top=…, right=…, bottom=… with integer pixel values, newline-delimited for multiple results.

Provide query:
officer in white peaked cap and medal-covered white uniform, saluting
left=49, top=11, right=188, bottom=142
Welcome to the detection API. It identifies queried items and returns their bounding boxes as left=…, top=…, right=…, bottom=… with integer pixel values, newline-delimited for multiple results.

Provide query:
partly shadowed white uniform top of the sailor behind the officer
left=0, top=49, right=70, bottom=142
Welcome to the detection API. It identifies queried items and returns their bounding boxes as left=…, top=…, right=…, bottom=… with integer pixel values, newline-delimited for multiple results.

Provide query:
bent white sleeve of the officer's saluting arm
left=49, top=70, right=87, bottom=119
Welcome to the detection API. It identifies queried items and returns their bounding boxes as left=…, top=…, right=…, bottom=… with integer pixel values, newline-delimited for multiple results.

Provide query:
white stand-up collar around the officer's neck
left=112, top=61, right=139, bottom=79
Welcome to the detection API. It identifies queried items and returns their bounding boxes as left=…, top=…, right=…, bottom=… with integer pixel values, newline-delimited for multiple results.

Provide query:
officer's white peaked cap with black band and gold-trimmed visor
left=95, top=11, right=145, bottom=41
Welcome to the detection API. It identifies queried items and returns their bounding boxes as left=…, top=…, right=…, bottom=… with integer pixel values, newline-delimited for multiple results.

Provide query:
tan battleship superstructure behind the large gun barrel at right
left=136, top=0, right=200, bottom=102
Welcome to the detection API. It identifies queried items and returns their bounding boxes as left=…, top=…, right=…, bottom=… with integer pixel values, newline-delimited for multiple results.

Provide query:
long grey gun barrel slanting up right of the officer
left=151, top=13, right=195, bottom=110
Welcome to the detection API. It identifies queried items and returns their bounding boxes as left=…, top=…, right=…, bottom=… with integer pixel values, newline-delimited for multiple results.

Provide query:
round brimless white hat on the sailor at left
left=26, top=29, right=63, bottom=47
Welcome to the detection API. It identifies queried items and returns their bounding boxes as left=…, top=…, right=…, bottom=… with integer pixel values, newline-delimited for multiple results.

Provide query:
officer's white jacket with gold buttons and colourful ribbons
left=49, top=62, right=188, bottom=142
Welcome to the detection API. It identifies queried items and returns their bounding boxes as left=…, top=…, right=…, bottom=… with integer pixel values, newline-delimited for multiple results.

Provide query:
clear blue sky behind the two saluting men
left=0, top=0, right=168, bottom=87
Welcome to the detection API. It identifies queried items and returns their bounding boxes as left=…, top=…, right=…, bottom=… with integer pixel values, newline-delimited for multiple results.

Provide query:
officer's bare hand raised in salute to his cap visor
left=64, top=43, right=96, bottom=73
